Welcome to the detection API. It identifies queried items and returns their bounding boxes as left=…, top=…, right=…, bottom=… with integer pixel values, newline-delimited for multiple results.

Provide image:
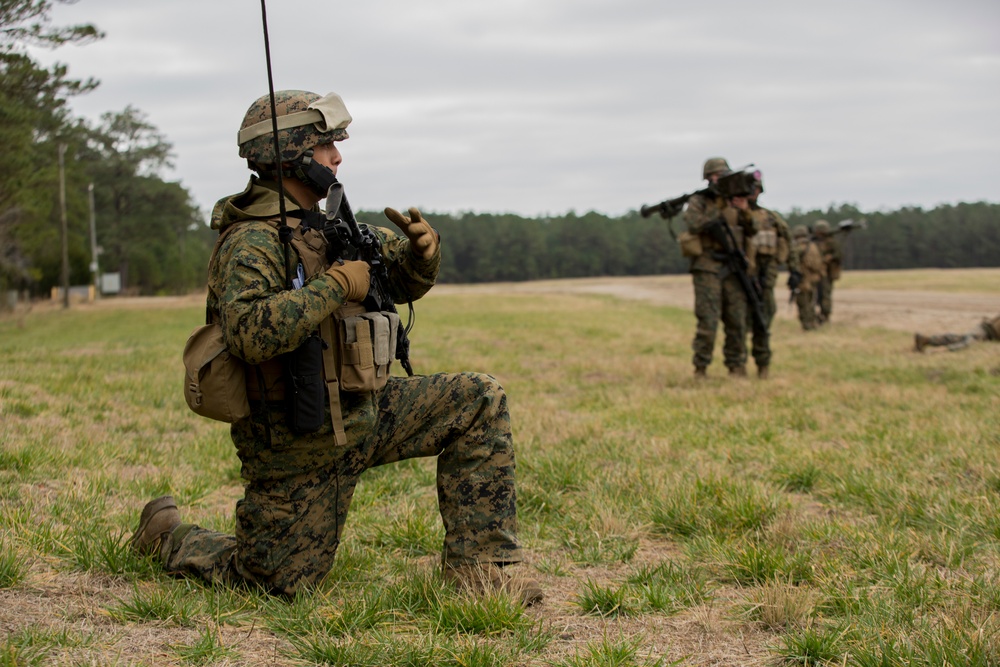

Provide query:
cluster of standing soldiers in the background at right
left=679, top=157, right=843, bottom=379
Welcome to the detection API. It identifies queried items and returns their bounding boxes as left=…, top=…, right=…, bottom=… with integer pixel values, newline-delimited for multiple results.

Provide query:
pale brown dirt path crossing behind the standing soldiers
left=435, top=275, right=1000, bottom=333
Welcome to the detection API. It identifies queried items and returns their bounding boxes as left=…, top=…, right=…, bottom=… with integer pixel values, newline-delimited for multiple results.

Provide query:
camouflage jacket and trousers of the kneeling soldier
left=160, top=177, right=521, bottom=595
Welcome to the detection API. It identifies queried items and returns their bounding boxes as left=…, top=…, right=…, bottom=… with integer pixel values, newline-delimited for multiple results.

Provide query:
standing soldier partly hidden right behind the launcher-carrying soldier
left=747, top=171, right=802, bottom=379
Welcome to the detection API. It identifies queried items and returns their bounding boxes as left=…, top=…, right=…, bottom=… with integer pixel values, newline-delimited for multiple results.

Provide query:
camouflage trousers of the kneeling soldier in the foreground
left=161, top=373, right=521, bottom=595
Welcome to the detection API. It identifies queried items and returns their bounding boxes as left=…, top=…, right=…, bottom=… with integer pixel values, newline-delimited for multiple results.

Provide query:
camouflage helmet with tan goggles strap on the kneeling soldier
left=237, top=90, right=351, bottom=164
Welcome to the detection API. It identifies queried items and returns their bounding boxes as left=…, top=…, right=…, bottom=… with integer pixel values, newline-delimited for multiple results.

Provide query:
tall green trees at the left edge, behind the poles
left=0, top=0, right=214, bottom=294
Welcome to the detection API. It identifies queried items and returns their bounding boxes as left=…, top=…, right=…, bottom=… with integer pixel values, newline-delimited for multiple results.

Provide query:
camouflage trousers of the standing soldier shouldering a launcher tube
left=691, top=271, right=747, bottom=368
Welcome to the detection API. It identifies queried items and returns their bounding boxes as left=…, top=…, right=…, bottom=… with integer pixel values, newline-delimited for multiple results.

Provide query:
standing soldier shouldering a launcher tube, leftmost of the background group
left=680, top=157, right=754, bottom=378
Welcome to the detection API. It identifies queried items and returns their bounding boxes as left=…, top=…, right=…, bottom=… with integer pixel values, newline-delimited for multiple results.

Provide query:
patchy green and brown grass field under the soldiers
left=0, top=274, right=1000, bottom=667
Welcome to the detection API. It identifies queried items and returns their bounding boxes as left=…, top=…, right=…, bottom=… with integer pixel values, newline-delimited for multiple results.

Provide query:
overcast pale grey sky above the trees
left=27, top=0, right=1000, bottom=216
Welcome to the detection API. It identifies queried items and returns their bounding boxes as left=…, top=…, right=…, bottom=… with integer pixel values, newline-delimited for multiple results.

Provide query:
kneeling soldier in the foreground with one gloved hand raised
left=132, top=90, right=542, bottom=604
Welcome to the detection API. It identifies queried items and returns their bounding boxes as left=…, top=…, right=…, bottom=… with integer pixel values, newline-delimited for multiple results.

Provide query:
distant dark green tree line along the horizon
left=358, top=202, right=1000, bottom=283
